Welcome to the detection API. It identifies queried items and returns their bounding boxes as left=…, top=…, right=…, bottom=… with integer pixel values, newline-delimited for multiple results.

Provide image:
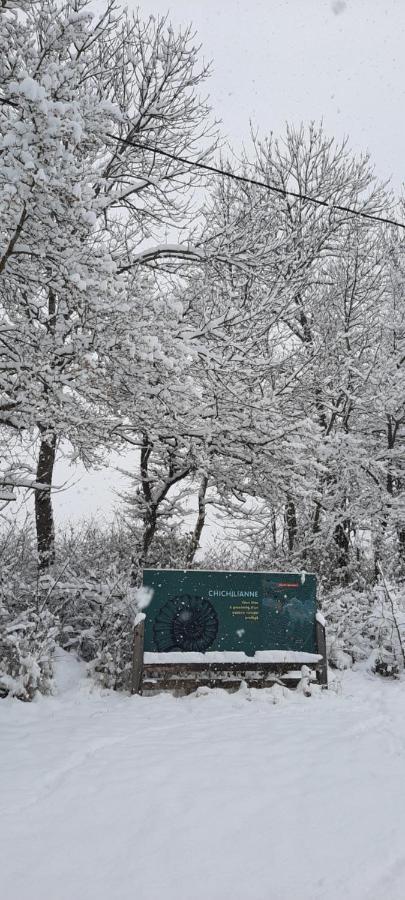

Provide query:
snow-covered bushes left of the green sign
left=0, top=521, right=131, bottom=700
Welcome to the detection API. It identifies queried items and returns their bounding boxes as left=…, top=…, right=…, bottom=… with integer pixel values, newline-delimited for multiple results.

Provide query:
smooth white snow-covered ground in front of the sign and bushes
left=0, top=654, right=405, bottom=900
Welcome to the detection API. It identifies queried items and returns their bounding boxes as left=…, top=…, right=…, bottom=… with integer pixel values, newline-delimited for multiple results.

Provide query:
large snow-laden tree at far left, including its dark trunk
left=0, top=0, right=212, bottom=567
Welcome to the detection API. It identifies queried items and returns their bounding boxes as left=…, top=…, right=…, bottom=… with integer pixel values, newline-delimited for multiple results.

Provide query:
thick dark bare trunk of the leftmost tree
left=35, top=434, right=56, bottom=572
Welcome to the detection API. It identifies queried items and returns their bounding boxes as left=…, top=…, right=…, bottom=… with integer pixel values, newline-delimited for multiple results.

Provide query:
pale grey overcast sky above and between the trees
left=49, top=0, right=405, bottom=521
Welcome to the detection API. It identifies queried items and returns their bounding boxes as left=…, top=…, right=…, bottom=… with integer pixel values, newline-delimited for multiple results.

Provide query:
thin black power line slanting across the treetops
left=107, top=134, right=405, bottom=229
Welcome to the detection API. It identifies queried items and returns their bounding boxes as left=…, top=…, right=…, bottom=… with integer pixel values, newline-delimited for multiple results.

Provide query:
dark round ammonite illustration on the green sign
left=153, top=594, right=218, bottom=653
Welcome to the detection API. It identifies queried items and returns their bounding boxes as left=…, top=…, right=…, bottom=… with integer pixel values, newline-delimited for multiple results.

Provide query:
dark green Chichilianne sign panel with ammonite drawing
left=143, top=569, right=318, bottom=656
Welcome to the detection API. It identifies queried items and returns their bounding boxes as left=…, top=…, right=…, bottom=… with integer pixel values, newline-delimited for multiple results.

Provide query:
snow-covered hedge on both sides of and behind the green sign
left=0, top=525, right=405, bottom=700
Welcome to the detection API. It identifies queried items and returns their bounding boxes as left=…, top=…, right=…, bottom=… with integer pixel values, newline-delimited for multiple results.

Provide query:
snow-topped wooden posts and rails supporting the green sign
left=131, top=613, right=328, bottom=696
